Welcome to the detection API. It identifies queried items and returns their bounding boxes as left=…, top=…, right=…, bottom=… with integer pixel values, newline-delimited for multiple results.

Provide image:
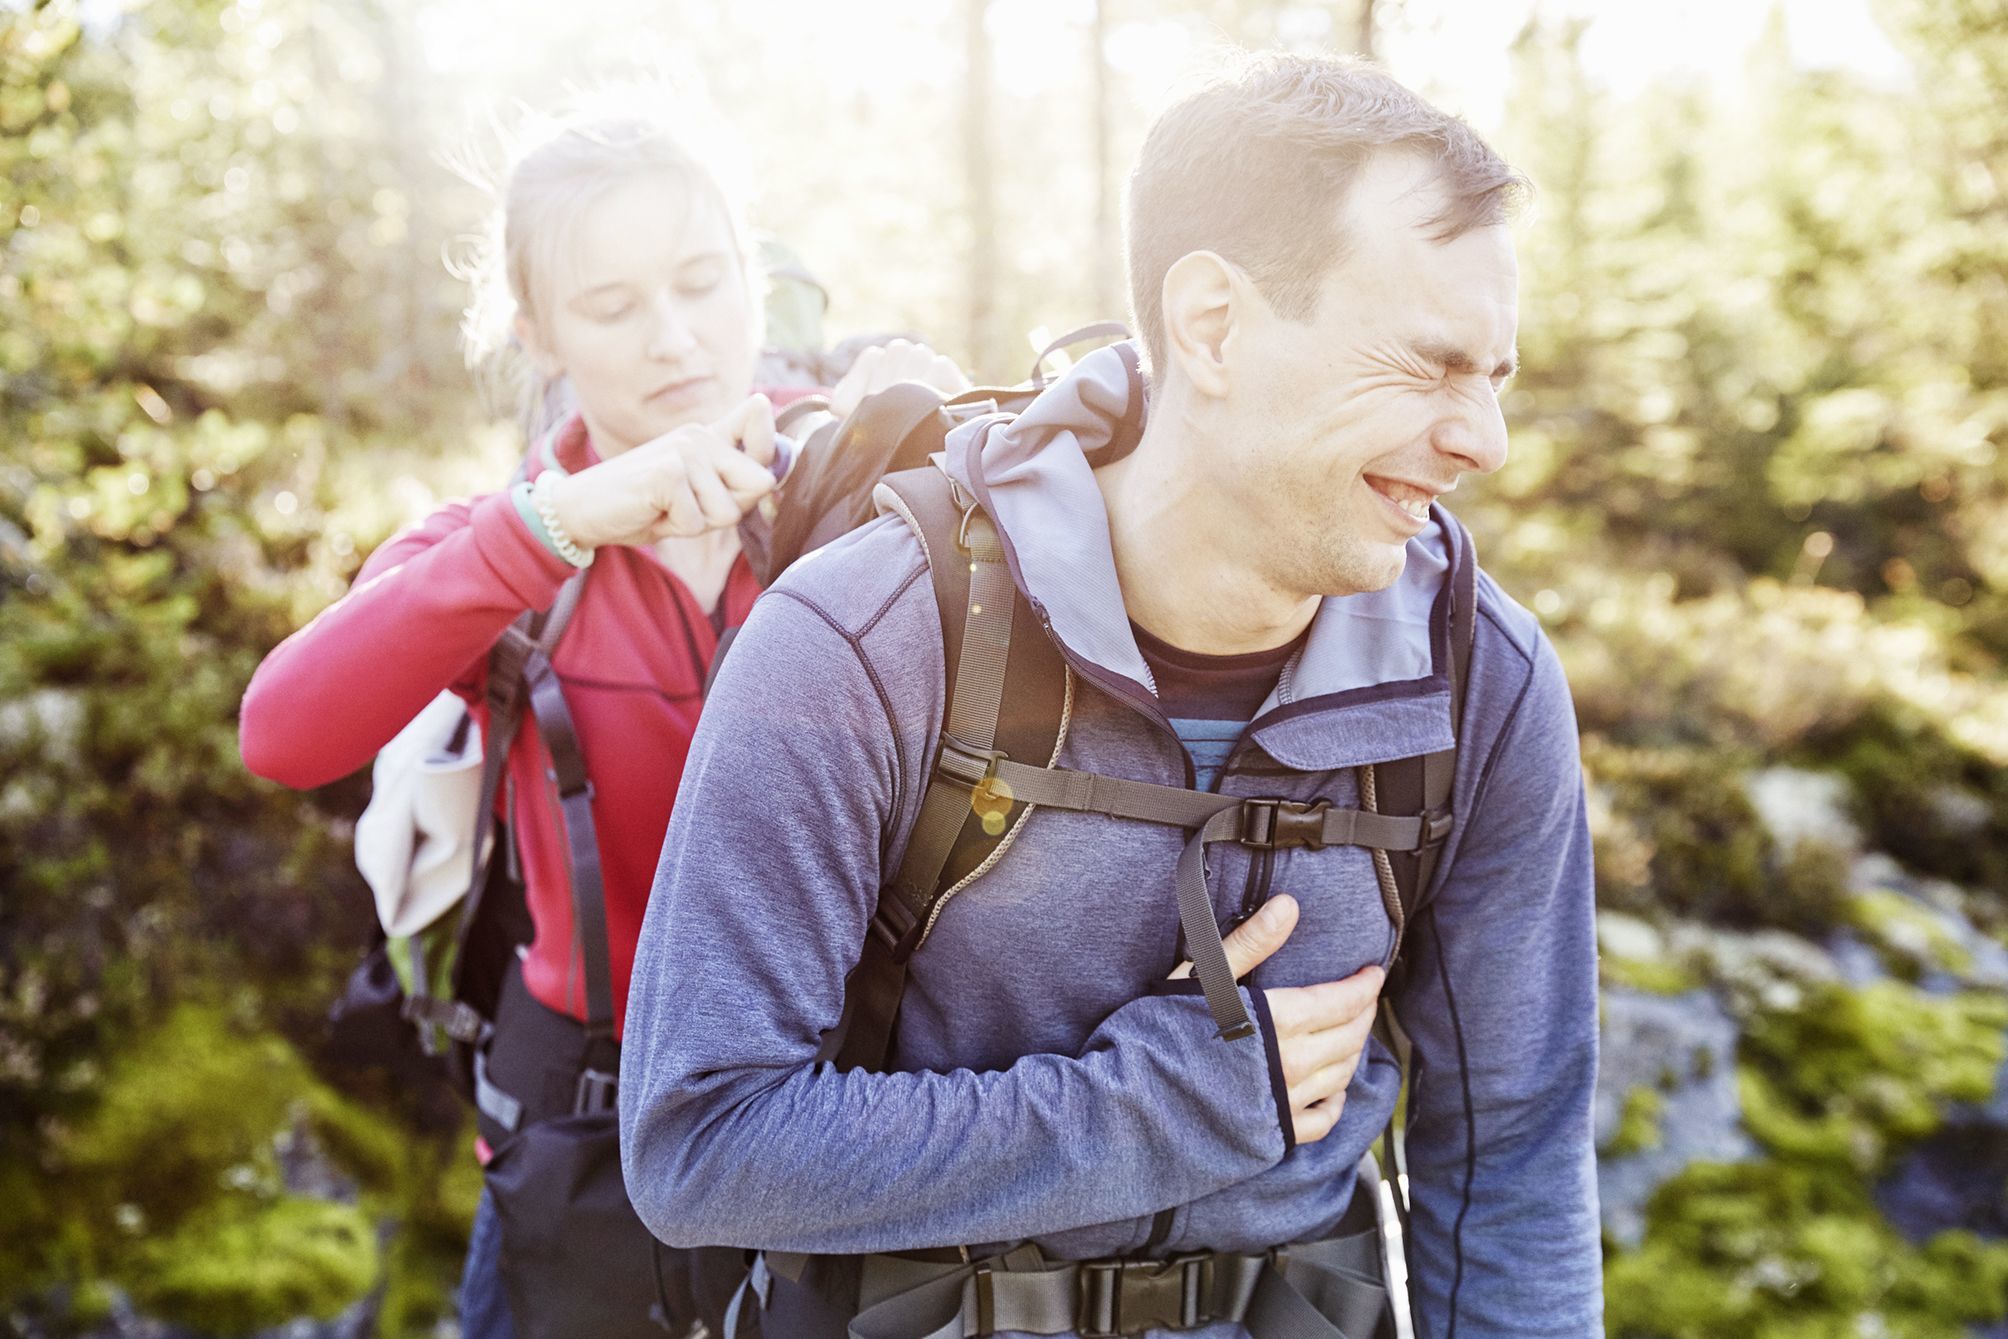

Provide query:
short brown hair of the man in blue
left=1128, top=54, right=1528, bottom=371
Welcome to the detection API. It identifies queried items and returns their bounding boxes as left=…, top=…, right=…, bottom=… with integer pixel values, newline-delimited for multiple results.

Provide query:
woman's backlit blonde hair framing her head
left=448, top=84, right=765, bottom=438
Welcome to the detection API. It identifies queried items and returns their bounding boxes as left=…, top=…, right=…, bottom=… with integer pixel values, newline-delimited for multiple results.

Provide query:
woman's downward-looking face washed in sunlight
left=518, top=173, right=759, bottom=456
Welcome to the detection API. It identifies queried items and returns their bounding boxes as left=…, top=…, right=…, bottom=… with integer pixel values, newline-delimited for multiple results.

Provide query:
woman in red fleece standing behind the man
left=241, top=99, right=966, bottom=1339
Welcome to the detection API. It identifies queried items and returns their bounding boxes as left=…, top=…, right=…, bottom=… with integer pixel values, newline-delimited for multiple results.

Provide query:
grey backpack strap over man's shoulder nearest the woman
left=819, top=466, right=1070, bottom=1070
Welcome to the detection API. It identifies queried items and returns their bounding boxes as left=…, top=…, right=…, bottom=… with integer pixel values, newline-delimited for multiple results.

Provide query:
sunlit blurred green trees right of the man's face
left=1500, top=9, right=2008, bottom=656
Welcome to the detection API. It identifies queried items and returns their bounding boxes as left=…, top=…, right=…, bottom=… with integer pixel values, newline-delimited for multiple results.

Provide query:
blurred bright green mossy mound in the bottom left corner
left=16, top=1004, right=480, bottom=1335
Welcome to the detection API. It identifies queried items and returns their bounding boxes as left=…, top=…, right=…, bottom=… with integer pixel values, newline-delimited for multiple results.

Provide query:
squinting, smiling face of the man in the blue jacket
left=1221, top=155, right=1518, bottom=596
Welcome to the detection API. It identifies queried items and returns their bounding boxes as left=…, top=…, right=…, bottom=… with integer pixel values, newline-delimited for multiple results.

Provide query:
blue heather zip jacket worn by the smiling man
left=620, top=351, right=1602, bottom=1339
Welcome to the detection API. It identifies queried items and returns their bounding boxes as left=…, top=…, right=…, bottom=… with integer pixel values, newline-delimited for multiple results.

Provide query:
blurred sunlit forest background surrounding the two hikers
left=0, top=0, right=2008, bottom=1339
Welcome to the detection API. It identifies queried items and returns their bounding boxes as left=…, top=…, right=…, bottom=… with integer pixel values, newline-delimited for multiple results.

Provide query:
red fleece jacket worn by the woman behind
left=239, top=420, right=759, bottom=1032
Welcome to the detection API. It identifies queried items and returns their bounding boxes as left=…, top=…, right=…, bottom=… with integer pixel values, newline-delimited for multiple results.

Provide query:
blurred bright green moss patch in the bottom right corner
left=1604, top=1162, right=2008, bottom=1339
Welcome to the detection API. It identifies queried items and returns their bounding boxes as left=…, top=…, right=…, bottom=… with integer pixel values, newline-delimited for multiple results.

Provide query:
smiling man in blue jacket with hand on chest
left=620, top=56, right=1602, bottom=1339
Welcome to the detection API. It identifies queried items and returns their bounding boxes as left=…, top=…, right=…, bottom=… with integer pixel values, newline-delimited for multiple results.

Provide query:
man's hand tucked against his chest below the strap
left=1173, top=893, right=1388, bottom=1144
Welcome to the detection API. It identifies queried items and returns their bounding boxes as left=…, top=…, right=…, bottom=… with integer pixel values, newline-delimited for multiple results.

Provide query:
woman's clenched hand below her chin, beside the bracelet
left=552, top=395, right=773, bottom=548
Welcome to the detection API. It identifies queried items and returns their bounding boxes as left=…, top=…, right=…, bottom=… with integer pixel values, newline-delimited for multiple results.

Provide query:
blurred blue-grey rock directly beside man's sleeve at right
left=1594, top=990, right=1755, bottom=1249
